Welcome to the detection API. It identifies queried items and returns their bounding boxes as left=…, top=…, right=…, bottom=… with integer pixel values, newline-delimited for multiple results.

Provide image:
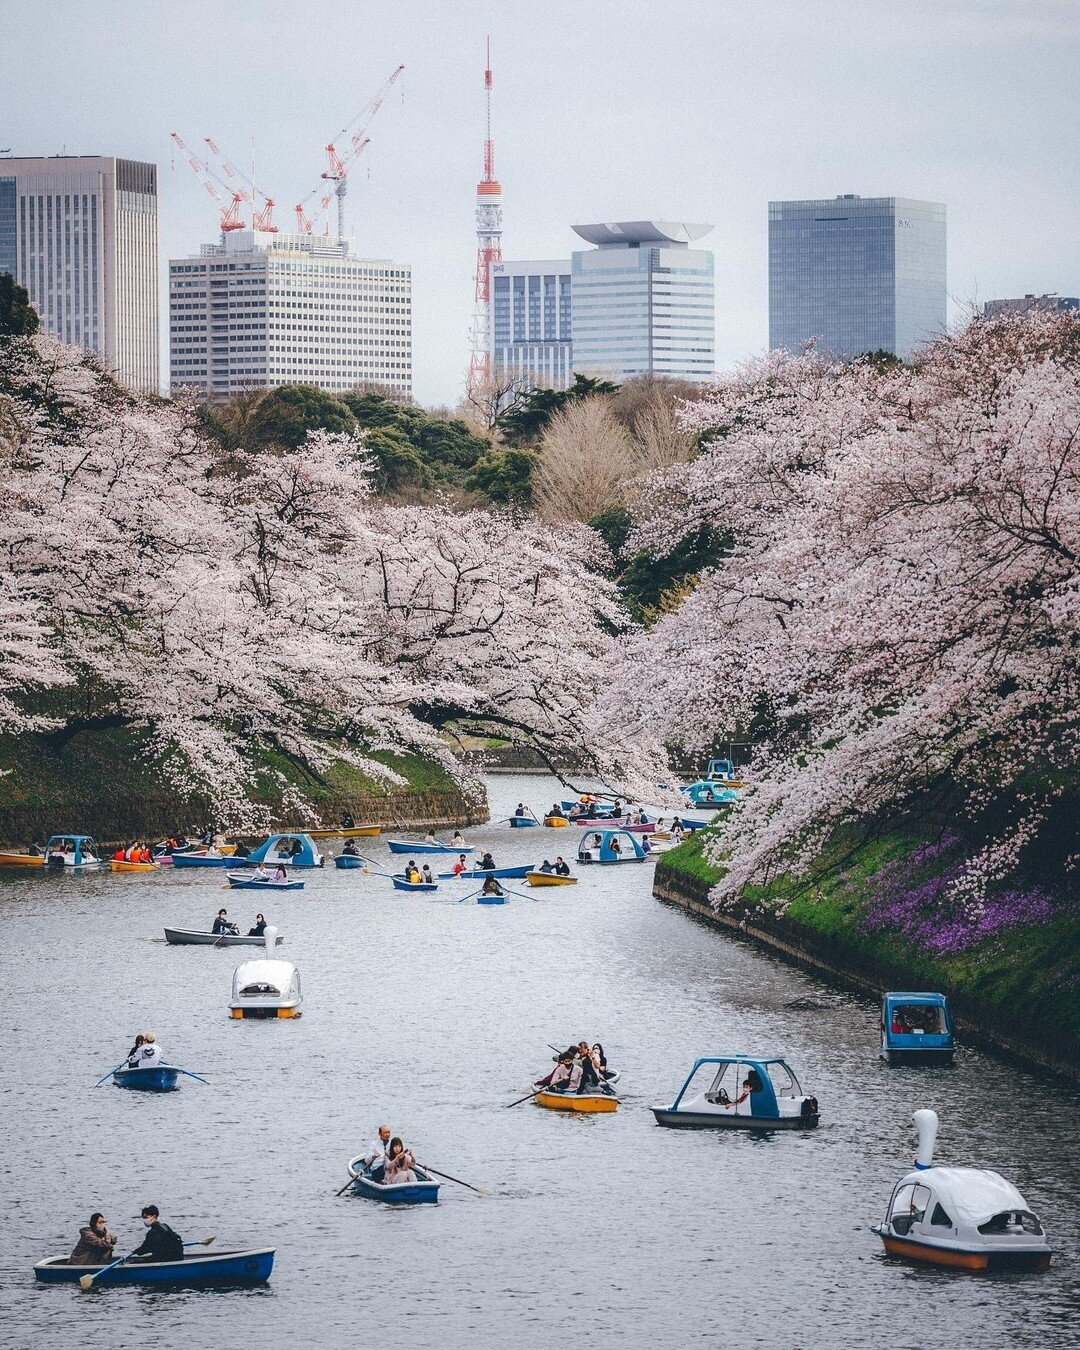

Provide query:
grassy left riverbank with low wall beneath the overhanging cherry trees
left=0, top=729, right=487, bottom=848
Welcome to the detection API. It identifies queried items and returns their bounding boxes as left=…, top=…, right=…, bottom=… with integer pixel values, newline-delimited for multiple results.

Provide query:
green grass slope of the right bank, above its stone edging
left=657, top=832, right=1080, bottom=1038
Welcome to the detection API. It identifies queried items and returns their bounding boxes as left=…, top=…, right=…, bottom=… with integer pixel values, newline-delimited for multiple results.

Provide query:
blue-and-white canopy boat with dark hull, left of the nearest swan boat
left=652, top=1054, right=818, bottom=1130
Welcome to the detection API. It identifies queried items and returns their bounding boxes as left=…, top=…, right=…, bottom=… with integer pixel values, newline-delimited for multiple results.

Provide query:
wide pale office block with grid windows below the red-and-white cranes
left=169, top=230, right=413, bottom=397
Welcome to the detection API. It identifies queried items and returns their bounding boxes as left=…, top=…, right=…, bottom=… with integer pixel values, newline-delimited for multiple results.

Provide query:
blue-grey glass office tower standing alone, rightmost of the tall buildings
left=768, top=194, right=946, bottom=359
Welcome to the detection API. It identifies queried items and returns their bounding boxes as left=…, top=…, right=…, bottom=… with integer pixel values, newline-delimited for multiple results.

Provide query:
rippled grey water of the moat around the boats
left=0, top=776, right=1080, bottom=1350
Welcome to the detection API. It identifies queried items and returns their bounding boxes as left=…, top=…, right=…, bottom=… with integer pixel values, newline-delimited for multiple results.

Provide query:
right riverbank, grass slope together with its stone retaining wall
left=653, top=834, right=1080, bottom=1081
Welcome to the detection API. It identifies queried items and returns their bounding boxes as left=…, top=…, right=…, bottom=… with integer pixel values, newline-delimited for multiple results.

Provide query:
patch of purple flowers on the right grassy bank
left=864, top=833, right=1056, bottom=956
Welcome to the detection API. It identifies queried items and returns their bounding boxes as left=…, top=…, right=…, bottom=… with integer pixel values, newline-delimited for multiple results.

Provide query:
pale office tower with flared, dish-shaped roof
left=570, top=220, right=716, bottom=381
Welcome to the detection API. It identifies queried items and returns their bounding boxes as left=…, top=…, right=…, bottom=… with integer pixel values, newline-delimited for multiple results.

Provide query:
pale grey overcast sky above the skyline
left=0, top=0, right=1080, bottom=405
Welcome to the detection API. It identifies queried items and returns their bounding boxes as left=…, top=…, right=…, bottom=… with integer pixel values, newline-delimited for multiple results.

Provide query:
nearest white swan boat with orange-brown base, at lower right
left=873, top=1111, right=1053, bottom=1270
